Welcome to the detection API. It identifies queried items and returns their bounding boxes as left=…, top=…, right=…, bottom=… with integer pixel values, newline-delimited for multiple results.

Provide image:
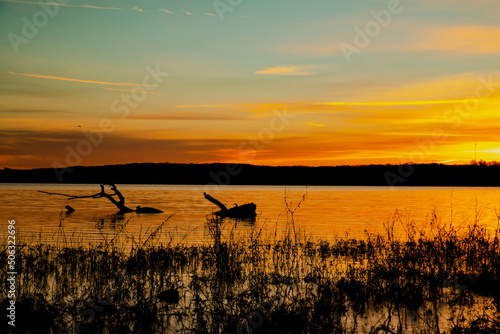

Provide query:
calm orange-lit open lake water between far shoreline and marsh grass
left=0, top=184, right=500, bottom=244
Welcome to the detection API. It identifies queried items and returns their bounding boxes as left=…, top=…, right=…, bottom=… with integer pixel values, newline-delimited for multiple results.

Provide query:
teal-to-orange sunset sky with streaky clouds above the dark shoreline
left=0, top=0, right=500, bottom=168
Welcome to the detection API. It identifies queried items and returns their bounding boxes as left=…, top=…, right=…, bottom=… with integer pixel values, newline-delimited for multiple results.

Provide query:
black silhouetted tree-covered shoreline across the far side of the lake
left=0, top=163, right=500, bottom=187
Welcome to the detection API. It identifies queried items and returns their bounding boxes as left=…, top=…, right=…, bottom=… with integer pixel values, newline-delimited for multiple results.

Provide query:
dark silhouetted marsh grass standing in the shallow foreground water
left=0, top=207, right=500, bottom=334
